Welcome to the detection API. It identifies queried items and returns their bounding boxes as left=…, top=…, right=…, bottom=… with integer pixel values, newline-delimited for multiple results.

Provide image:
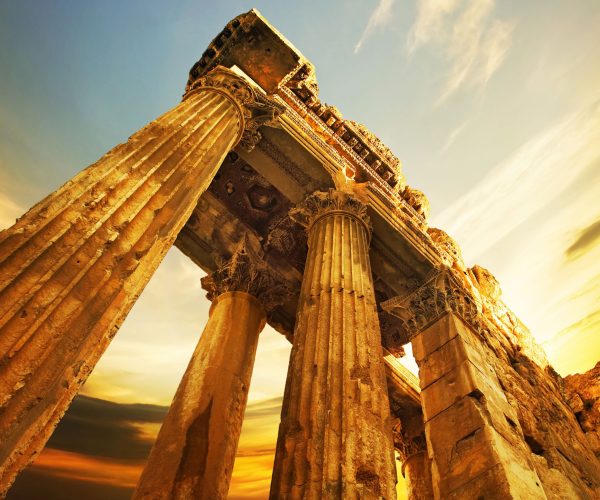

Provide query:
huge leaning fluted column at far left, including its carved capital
left=0, top=68, right=280, bottom=496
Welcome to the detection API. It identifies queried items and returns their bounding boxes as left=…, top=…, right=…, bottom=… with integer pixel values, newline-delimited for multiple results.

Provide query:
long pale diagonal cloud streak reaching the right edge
left=433, top=101, right=600, bottom=260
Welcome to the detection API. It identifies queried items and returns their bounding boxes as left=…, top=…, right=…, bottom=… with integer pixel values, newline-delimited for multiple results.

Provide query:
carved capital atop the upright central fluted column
left=289, top=189, right=371, bottom=235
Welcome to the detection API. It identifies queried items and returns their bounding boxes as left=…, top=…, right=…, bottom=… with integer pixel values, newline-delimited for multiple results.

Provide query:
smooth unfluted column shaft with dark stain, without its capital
left=133, top=292, right=265, bottom=500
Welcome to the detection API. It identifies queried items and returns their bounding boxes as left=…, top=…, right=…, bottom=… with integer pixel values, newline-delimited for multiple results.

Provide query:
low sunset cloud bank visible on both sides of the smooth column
left=8, top=395, right=282, bottom=500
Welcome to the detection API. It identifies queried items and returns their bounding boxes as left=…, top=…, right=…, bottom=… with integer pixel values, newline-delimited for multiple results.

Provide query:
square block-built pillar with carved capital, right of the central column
left=383, top=271, right=546, bottom=499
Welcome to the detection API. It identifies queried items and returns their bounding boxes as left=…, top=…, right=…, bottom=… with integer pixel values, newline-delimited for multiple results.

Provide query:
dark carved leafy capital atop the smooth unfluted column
left=201, top=236, right=290, bottom=313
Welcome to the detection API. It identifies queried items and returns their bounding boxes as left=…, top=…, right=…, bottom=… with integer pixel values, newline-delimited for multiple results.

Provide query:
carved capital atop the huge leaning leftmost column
left=183, top=66, right=285, bottom=151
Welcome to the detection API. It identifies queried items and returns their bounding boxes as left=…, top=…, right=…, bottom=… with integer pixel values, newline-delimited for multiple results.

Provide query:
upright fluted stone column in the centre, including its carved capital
left=271, top=190, right=396, bottom=499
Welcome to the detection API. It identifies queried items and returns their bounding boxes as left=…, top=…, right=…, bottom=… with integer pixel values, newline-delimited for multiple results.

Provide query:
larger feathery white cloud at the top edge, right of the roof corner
left=407, top=0, right=515, bottom=104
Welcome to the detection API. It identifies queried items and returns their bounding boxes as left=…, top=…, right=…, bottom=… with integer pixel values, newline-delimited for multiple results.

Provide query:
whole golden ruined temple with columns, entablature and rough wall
left=0, top=10, right=600, bottom=499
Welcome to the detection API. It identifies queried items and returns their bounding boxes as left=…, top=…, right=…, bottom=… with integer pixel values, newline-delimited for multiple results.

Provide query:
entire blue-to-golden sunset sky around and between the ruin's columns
left=0, top=0, right=600, bottom=499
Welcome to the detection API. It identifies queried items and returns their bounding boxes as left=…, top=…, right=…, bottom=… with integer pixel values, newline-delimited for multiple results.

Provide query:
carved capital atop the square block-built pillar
left=381, top=270, right=486, bottom=340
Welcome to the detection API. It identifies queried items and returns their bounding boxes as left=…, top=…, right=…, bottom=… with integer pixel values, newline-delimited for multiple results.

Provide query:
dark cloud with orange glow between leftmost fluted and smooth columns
left=8, top=396, right=168, bottom=500
